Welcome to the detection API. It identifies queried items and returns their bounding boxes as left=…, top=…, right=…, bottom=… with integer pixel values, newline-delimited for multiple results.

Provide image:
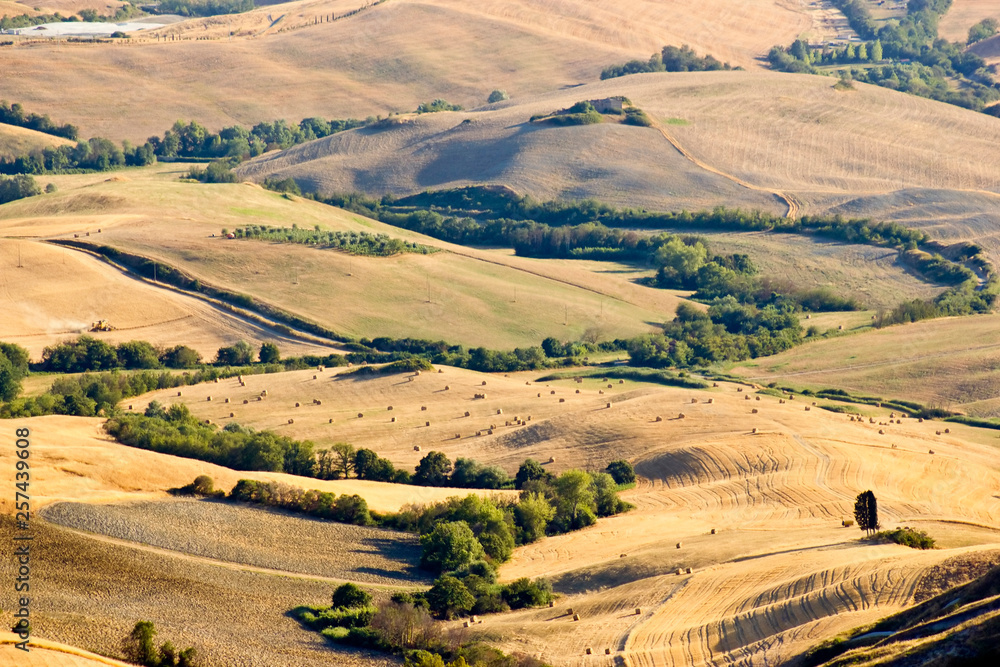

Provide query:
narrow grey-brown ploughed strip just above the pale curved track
left=42, top=500, right=427, bottom=585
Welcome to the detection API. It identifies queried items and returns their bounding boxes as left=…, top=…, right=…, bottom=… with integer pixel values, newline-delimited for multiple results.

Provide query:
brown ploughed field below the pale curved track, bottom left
left=0, top=515, right=396, bottom=667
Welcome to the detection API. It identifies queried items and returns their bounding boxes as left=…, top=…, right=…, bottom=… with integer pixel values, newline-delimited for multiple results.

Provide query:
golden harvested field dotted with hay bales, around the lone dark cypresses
left=39, top=367, right=1000, bottom=665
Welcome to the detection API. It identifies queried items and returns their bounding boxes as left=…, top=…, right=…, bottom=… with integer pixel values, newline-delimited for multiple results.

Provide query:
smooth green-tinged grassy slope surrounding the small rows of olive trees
left=0, top=165, right=678, bottom=352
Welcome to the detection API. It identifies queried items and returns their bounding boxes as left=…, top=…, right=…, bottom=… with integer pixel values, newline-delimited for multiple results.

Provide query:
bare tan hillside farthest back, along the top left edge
left=0, top=0, right=811, bottom=141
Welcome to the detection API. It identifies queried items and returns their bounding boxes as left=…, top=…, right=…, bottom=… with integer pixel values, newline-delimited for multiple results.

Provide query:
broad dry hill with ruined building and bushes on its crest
left=240, top=72, right=1000, bottom=252
